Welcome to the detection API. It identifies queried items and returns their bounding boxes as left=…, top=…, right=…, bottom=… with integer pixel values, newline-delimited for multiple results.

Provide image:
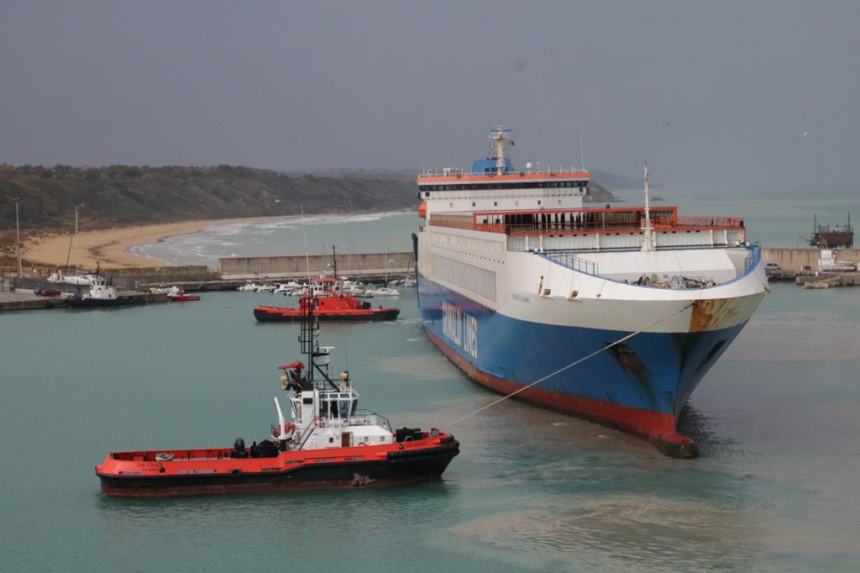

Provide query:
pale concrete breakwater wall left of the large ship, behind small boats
left=218, top=252, right=415, bottom=278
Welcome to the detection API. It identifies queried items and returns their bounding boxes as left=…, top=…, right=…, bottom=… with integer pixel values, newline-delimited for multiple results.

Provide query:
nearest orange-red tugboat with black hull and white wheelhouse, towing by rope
left=96, top=295, right=460, bottom=497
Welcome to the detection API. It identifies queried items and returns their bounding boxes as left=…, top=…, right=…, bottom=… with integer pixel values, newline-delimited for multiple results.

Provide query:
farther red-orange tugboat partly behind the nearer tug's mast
left=254, top=278, right=400, bottom=322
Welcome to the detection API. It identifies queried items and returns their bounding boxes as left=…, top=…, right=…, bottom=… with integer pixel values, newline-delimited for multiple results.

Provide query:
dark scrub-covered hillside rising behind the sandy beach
left=0, top=165, right=417, bottom=229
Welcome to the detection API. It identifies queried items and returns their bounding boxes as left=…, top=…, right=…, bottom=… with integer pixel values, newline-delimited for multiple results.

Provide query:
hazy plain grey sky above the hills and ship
left=0, top=0, right=860, bottom=186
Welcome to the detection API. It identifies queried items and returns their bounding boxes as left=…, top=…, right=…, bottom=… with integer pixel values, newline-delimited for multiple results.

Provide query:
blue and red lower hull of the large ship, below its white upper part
left=418, top=273, right=745, bottom=457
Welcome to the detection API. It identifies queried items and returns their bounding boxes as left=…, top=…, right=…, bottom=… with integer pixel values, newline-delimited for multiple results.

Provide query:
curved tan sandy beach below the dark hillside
left=22, top=216, right=290, bottom=268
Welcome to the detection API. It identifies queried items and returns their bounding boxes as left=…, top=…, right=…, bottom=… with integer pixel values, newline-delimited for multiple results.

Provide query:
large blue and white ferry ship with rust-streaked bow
left=415, top=128, right=768, bottom=458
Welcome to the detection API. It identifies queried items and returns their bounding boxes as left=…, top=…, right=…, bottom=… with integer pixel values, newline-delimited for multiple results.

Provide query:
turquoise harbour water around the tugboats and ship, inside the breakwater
left=0, top=285, right=860, bottom=573
